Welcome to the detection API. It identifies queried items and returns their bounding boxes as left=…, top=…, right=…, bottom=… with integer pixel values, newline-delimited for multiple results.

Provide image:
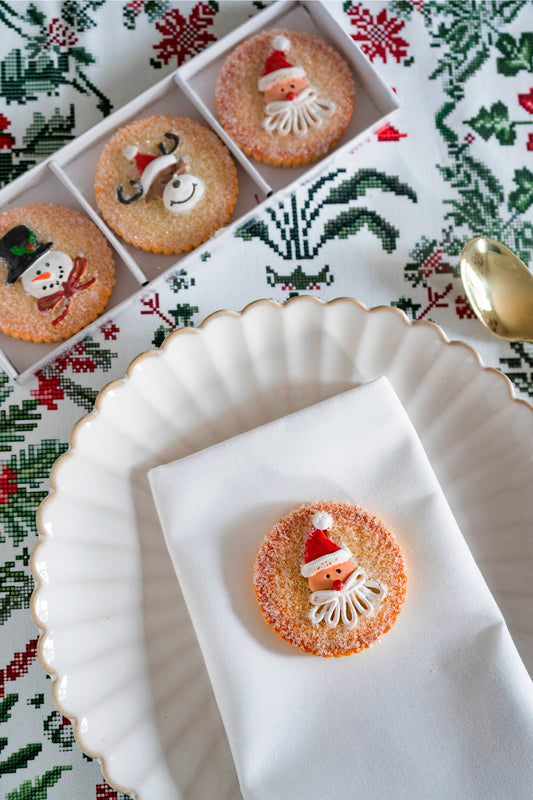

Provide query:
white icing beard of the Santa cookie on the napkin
left=309, top=569, right=386, bottom=628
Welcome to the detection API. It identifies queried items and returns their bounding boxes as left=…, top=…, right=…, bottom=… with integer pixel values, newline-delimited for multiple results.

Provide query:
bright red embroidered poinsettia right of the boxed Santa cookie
left=346, top=3, right=409, bottom=64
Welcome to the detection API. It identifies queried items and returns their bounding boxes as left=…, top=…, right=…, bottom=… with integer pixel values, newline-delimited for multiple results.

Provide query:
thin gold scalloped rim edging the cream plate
left=30, top=295, right=533, bottom=800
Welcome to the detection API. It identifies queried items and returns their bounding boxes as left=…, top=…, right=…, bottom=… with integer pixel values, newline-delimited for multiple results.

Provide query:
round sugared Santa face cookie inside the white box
left=216, top=31, right=354, bottom=167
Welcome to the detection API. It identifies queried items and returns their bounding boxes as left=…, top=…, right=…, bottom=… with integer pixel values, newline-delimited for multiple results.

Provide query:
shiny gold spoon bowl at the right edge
left=461, top=236, right=533, bottom=342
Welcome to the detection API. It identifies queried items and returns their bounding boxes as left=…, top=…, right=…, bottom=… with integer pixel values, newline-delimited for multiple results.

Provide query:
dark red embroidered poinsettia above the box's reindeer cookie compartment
left=154, top=3, right=216, bottom=67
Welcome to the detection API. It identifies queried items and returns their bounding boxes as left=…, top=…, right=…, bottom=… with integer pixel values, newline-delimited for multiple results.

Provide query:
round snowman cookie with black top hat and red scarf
left=0, top=203, right=115, bottom=342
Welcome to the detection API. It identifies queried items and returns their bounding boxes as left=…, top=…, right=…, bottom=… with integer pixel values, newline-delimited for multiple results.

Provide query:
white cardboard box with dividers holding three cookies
left=0, top=0, right=399, bottom=380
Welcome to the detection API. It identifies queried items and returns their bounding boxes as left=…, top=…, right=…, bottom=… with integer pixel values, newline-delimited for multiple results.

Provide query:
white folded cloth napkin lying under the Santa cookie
left=150, top=379, right=533, bottom=800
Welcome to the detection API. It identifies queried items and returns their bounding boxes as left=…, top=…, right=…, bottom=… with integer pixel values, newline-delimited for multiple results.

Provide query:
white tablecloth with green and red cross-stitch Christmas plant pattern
left=0, top=0, right=533, bottom=800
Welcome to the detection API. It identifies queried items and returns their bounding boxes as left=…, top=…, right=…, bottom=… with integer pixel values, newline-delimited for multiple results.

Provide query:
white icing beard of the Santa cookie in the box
left=263, top=86, right=335, bottom=136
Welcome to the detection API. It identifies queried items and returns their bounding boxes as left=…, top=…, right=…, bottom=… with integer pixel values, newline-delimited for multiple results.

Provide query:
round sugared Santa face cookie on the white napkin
left=254, top=503, right=406, bottom=656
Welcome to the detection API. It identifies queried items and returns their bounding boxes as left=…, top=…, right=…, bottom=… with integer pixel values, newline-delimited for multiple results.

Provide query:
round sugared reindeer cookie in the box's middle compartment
left=95, top=116, right=237, bottom=254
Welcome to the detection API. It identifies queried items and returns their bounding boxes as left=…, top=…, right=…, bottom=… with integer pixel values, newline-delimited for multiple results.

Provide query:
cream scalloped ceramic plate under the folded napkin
left=32, top=298, right=533, bottom=800
